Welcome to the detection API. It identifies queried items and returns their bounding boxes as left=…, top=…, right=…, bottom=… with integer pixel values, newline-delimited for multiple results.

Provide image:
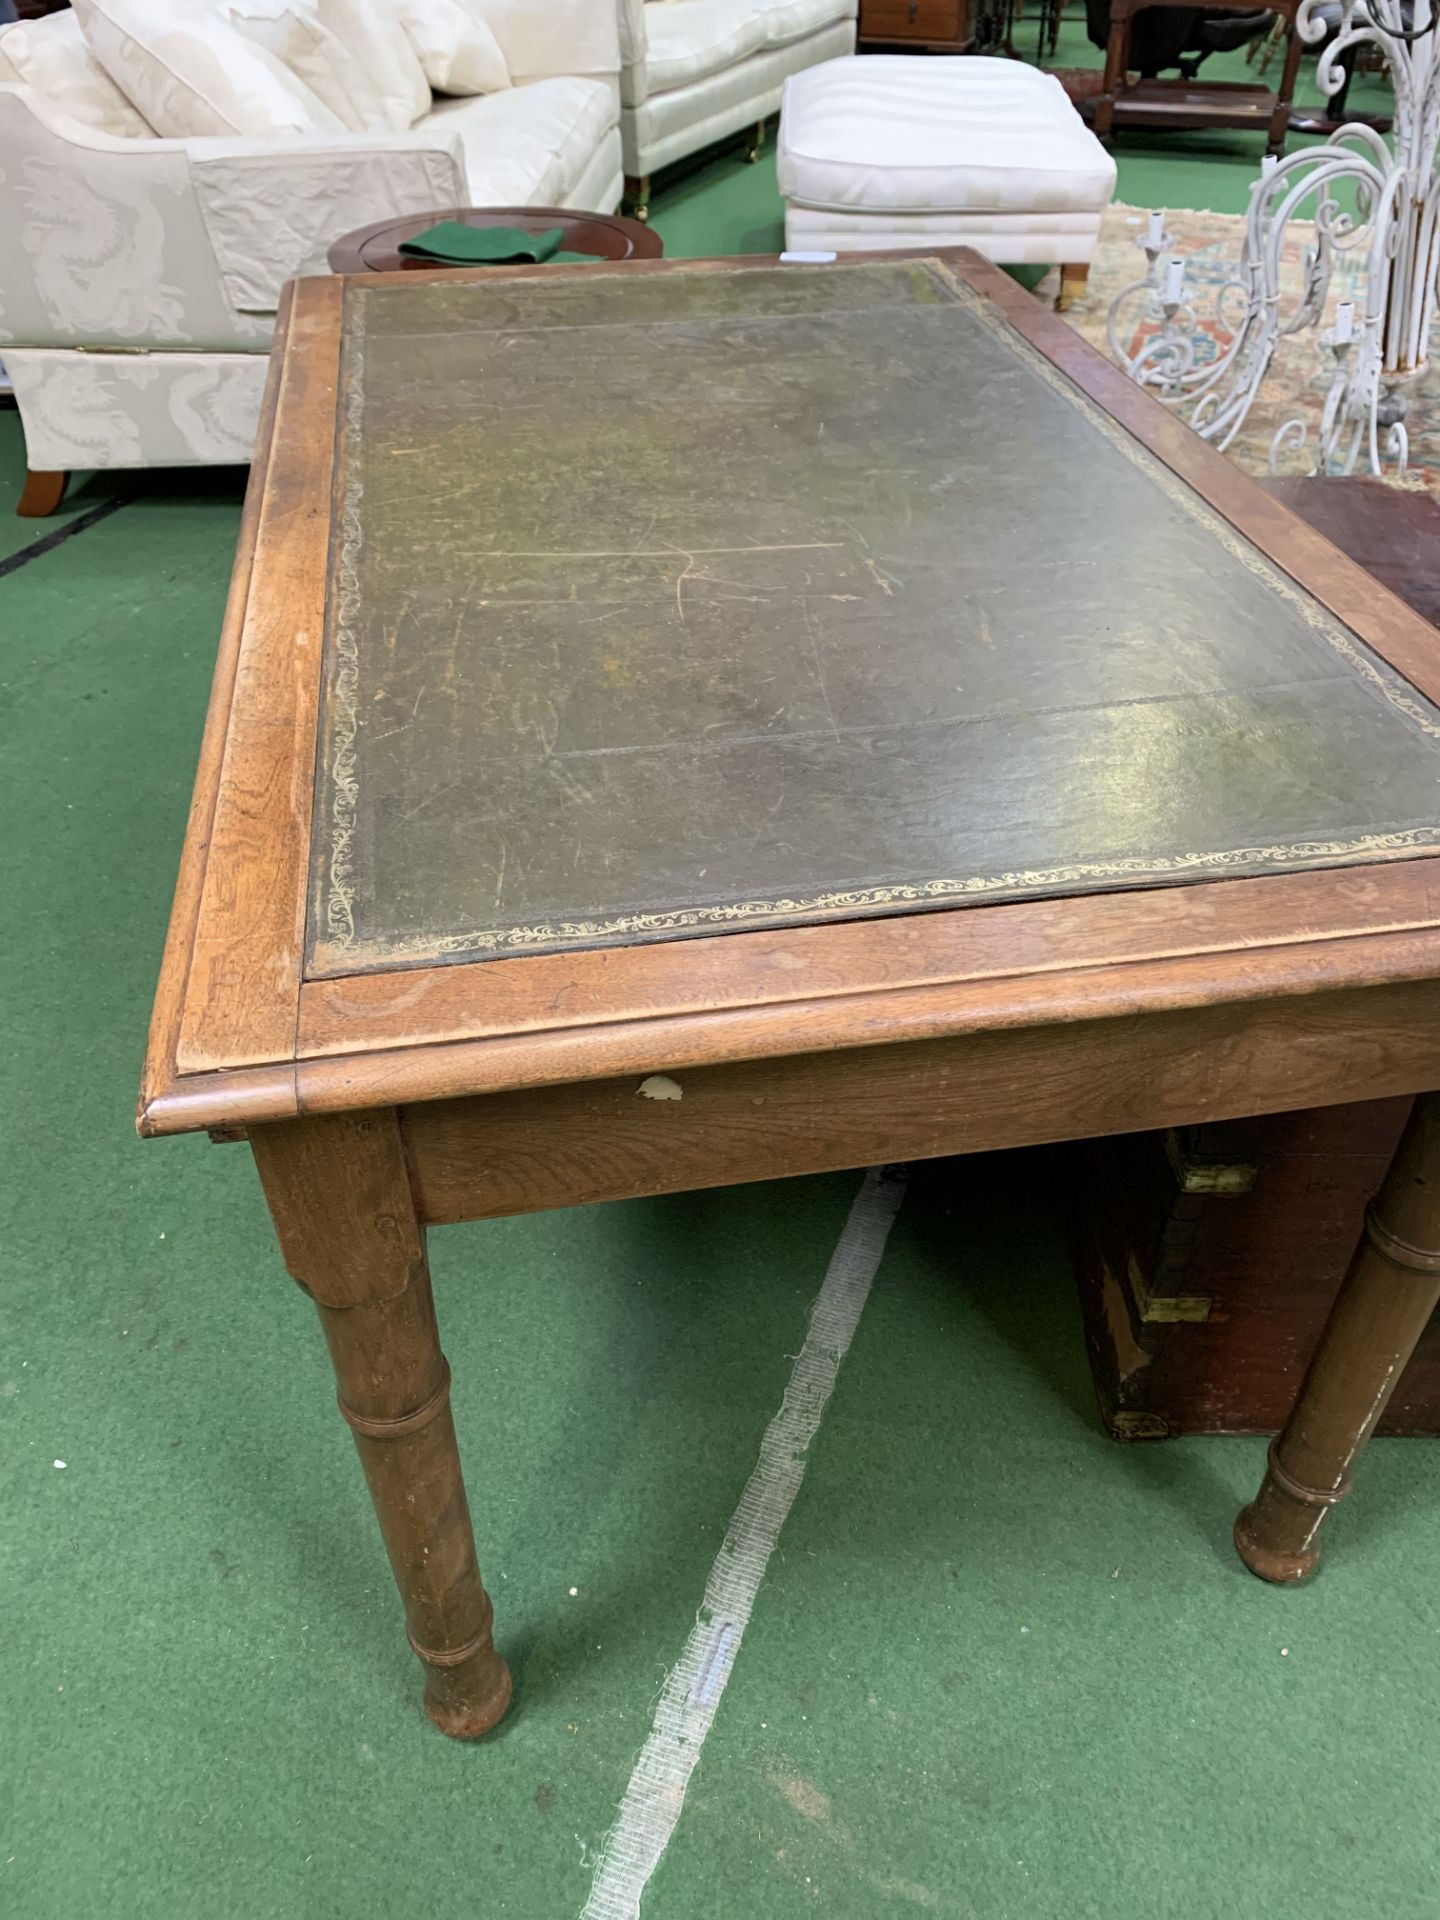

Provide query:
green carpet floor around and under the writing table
left=0, top=56, right=1440, bottom=1920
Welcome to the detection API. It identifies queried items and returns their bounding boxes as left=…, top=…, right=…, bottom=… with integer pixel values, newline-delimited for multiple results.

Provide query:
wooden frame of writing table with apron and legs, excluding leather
left=138, top=250, right=1440, bottom=1736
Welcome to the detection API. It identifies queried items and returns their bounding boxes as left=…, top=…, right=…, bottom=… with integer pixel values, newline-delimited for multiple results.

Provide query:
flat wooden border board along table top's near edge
left=298, top=860, right=1440, bottom=1060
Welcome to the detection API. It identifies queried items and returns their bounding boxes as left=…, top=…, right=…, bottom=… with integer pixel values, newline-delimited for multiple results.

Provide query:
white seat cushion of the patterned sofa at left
left=428, top=79, right=620, bottom=207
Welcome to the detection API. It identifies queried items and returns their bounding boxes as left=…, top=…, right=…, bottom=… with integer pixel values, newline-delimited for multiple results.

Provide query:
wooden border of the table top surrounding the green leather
left=140, top=253, right=1440, bottom=1133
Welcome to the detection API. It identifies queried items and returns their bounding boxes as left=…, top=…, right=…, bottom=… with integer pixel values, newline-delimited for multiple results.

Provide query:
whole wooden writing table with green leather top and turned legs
left=140, top=252, right=1440, bottom=1736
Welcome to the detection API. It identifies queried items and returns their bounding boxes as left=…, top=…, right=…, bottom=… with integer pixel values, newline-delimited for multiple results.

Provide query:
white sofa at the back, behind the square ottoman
left=618, top=0, right=858, bottom=219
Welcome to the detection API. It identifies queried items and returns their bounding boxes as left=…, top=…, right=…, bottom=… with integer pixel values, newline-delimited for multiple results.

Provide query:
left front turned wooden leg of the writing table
left=252, top=1112, right=511, bottom=1740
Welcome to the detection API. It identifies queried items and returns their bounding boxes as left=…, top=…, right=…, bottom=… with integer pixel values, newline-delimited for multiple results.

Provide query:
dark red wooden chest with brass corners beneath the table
left=1064, top=476, right=1440, bottom=1440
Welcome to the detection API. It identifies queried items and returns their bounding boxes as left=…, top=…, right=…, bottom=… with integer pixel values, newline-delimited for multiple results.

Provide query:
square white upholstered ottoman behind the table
left=780, top=54, right=1116, bottom=307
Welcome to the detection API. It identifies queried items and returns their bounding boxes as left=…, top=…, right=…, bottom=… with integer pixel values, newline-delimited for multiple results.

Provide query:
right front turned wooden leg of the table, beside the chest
left=1235, top=1092, right=1440, bottom=1580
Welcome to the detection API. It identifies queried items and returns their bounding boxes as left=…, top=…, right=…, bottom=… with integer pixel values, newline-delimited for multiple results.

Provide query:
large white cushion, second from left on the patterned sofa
left=75, top=0, right=344, bottom=140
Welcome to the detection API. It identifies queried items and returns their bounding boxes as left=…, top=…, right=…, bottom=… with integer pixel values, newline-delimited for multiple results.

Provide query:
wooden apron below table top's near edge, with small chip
left=401, top=981, right=1440, bottom=1223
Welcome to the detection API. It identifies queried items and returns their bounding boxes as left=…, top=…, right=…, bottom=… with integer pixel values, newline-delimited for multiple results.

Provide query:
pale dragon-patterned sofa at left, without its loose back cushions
left=0, top=0, right=622, bottom=515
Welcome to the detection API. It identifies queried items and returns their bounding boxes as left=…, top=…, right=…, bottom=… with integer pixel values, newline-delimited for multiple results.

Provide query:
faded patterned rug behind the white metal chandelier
left=1037, top=204, right=1440, bottom=493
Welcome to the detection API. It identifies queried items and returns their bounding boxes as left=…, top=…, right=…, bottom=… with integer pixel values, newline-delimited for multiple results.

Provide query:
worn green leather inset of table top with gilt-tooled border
left=307, top=261, right=1440, bottom=975
